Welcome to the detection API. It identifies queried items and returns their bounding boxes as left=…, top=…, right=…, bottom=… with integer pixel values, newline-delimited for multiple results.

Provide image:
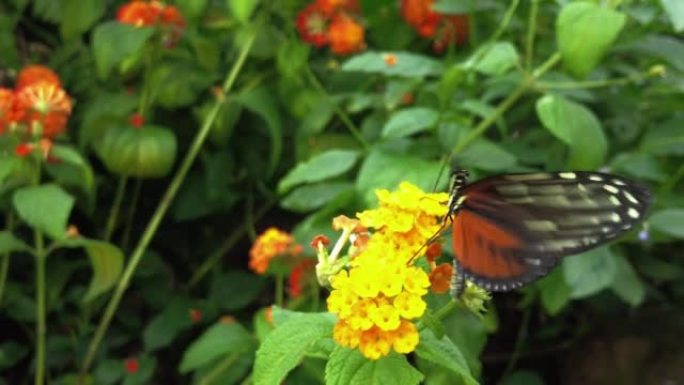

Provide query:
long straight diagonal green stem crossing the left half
left=80, top=31, right=256, bottom=379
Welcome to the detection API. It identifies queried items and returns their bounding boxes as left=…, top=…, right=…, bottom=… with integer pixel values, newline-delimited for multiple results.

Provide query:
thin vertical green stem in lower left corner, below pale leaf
left=34, top=230, right=47, bottom=385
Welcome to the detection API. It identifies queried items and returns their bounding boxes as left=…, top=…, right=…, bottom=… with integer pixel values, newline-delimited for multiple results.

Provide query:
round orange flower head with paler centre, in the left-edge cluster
left=16, top=82, right=71, bottom=138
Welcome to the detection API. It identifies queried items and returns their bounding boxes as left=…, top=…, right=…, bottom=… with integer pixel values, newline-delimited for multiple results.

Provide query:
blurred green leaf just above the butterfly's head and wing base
left=457, top=139, right=517, bottom=171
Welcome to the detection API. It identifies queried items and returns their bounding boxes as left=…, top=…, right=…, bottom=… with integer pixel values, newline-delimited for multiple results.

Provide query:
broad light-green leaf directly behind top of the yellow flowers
left=356, top=150, right=443, bottom=204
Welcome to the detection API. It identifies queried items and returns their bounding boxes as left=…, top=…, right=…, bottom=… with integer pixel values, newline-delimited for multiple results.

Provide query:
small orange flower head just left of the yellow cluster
left=249, top=227, right=302, bottom=274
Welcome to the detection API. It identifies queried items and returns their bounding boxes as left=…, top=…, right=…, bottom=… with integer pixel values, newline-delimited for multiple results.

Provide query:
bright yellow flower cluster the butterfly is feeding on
left=328, top=183, right=448, bottom=359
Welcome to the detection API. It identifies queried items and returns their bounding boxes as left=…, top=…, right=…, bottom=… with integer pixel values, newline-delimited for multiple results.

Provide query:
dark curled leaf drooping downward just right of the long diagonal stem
left=237, top=87, right=283, bottom=176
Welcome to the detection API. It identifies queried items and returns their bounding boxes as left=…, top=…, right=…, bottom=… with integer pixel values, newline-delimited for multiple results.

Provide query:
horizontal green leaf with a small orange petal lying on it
left=342, top=52, right=444, bottom=77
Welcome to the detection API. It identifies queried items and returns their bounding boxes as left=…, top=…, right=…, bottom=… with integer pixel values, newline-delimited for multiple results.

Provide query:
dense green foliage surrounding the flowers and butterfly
left=0, top=0, right=684, bottom=385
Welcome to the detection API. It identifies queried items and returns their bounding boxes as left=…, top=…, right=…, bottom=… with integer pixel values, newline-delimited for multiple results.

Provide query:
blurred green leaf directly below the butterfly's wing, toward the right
left=563, top=246, right=617, bottom=298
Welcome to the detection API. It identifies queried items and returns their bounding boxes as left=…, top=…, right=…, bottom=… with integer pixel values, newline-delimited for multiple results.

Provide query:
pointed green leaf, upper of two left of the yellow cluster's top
left=280, top=182, right=354, bottom=213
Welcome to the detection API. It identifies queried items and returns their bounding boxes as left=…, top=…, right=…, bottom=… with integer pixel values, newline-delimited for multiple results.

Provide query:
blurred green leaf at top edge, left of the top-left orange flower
left=59, top=0, right=105, bottom=40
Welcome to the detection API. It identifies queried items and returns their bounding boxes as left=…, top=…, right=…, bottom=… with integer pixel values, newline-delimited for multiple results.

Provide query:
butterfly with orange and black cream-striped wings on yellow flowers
left=445, top=169, right=652, bottom=294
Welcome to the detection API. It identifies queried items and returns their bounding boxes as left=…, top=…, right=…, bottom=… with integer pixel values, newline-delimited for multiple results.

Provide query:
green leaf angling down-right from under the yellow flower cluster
left=416, top=330, right=478, bottom=385
